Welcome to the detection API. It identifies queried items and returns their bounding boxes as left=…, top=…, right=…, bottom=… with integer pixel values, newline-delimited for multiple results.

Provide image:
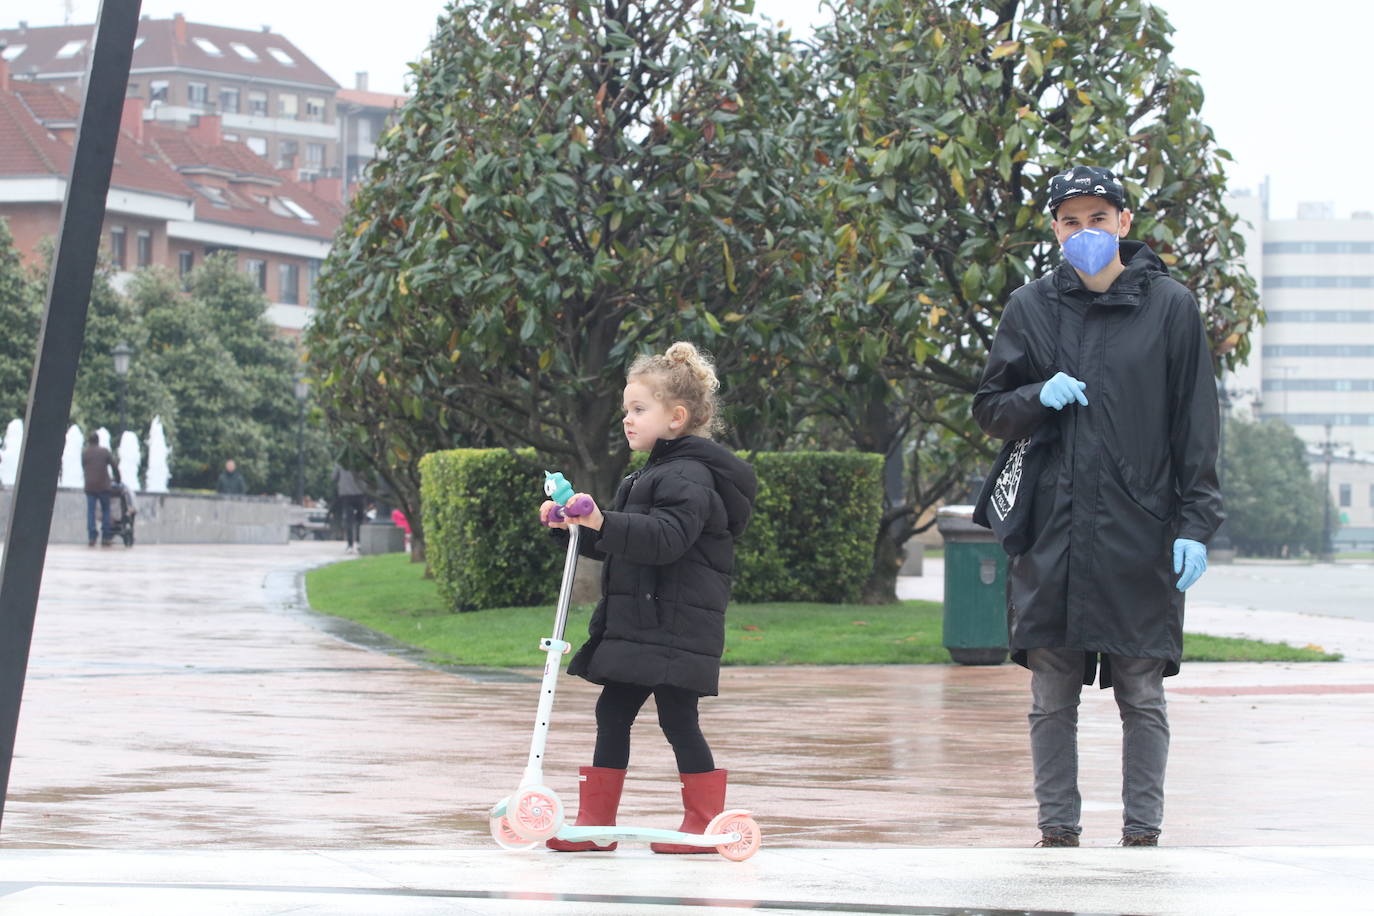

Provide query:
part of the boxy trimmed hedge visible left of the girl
left=420, top=449, right=563, bottom=611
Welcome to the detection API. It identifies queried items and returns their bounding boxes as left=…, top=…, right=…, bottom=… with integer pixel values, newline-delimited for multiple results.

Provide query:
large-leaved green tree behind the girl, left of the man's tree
left=309, top=0, right=823, bottom=552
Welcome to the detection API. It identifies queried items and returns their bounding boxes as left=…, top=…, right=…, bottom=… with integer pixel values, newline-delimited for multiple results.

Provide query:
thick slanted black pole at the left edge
left=0, top=0, right=140, bottom=818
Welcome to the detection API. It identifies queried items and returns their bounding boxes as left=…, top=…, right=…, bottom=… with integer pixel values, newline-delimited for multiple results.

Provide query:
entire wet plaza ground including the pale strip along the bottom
left=0, top=542, right=1374, bottom=913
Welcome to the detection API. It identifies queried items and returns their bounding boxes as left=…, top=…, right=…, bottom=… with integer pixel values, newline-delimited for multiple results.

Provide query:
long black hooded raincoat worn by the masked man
left=973, top=242, right=1224, bottom=687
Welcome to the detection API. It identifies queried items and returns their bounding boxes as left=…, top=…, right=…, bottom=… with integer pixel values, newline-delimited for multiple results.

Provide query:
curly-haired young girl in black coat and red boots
left=540, top=342, right=757, bottom=853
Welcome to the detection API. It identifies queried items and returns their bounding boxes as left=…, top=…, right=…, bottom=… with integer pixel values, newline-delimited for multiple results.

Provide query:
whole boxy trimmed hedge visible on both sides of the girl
left=420, top=449, right=882, bottom=611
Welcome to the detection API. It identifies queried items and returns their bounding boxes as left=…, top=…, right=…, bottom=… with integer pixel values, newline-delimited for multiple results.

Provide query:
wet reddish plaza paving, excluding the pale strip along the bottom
left=4, top=544, right=1374, bottom=851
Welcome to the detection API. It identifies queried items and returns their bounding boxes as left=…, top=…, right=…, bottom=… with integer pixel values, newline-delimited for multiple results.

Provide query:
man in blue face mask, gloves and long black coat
left=973, top=166, right=1224, bottom=846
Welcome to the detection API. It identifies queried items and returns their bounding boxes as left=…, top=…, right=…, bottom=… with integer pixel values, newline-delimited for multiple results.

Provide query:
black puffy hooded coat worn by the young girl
left=567, top=435, right=758, bottom=696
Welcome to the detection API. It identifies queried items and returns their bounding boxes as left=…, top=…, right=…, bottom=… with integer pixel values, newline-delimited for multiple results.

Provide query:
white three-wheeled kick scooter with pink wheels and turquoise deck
left=488, top=471, right=763, bottom=862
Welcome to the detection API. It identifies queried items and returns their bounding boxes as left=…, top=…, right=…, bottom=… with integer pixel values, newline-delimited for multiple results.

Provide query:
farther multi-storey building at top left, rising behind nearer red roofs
left=0, top=14, right=341, bottom=180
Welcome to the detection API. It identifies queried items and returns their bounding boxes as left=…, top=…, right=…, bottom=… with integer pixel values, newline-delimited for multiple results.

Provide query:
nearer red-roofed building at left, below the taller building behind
left=0, top=65, right=342, bottom=336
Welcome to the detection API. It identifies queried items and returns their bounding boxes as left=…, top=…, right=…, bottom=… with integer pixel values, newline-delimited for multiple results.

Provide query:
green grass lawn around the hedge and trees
left=305, top=553, right=1340, bottom=667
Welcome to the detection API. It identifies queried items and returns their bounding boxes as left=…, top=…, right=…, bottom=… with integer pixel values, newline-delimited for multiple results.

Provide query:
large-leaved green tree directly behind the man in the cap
left=811, top=0, right=1260, bottom=597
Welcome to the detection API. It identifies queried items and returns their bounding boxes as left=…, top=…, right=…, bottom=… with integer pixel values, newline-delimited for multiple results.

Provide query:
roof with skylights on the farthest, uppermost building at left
left=0, top=19, right=339, bottom=89
